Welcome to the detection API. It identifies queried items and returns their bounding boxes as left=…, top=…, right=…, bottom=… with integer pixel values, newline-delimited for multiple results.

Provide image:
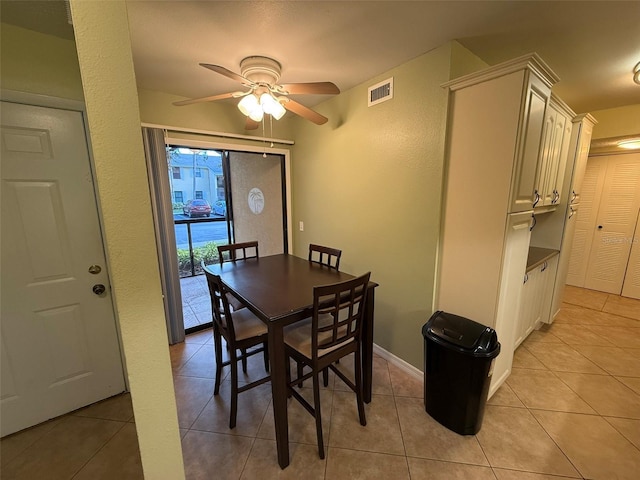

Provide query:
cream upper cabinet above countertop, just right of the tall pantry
left=534, top=94, right=575, bottom=209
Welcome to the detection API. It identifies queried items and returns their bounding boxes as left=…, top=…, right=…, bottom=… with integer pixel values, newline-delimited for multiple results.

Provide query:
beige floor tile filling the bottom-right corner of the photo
left=532, top=410, right=640, bottom=480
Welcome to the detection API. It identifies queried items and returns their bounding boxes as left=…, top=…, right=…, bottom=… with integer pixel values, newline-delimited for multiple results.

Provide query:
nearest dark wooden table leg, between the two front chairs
left=268, top=323, right=289, bottom=468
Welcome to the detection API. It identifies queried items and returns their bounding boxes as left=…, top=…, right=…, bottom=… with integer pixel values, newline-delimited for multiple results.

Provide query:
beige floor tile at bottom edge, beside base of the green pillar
left=182, top=430, right=254, bottom=480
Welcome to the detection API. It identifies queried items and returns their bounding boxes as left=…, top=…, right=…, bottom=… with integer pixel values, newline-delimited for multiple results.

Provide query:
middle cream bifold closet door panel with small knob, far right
left=584, top=154, right=640, bottom=295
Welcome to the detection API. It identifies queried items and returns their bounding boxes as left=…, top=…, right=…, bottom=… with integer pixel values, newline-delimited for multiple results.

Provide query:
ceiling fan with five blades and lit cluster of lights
left=173, top=56, right=340, bottom=130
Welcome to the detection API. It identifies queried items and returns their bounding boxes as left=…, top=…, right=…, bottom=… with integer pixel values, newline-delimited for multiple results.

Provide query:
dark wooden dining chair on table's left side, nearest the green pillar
left=205, top=270, right=271, bottom=428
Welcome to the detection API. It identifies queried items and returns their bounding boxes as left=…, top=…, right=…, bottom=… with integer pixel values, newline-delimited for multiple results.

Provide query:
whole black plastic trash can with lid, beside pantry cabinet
left=422, top=311, right=500, bottom=435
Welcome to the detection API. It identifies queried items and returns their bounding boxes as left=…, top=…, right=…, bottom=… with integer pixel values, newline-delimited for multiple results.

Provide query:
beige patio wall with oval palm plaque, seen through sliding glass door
left=228, top=152, right=287, bottom=256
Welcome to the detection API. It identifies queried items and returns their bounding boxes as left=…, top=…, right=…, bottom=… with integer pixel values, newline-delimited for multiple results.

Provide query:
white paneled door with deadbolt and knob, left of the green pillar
left=0, top=101, right=125, bottom=436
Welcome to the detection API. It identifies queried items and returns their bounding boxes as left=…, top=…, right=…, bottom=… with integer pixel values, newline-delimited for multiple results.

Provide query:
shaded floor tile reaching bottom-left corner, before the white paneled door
left=2, top=415, right=125, bottom=480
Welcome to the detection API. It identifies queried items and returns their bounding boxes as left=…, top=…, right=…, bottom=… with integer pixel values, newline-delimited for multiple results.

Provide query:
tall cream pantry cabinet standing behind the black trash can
left=434, top=55, right=557, bottom=395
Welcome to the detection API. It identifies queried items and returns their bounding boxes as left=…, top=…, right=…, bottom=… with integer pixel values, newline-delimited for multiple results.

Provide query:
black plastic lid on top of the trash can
left=422, top=311, right=500, bottom=355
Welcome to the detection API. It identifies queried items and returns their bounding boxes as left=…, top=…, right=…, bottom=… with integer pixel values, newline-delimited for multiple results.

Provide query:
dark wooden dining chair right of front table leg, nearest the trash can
left=284, top=272, right=371, bottom=458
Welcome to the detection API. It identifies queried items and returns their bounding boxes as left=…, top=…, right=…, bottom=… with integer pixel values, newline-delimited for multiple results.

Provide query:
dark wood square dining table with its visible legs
left=205, top=254, right=378, bottom=468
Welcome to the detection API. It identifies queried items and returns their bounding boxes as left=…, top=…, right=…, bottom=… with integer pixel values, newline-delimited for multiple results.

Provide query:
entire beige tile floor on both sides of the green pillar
left=0, top=287, right=640, bottom=480
